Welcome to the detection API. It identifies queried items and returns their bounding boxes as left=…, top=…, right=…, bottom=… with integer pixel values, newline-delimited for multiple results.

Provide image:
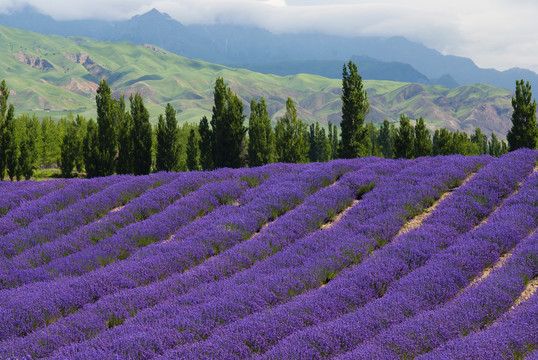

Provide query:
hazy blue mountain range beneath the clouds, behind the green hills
left=0, top=8, right=538, bottom=90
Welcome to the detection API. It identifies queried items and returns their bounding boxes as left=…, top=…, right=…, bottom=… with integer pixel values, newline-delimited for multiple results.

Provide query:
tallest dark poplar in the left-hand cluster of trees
left=95, top=79, right=118, bottom=176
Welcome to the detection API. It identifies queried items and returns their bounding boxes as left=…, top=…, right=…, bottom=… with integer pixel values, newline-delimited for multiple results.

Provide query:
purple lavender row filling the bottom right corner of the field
left=420, top=282, right=538, bottom=360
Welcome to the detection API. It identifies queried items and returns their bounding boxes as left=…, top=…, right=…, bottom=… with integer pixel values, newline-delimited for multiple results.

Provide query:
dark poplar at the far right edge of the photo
left=506, top=79, right=538, bottom=151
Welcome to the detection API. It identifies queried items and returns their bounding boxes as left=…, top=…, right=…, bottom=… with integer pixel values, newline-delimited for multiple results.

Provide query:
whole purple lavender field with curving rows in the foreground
left=0, top=150, right=538, bottom=360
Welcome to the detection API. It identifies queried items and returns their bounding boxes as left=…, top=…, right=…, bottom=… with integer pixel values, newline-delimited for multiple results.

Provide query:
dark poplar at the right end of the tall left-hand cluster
left=129, top=93, right=153, bottom=175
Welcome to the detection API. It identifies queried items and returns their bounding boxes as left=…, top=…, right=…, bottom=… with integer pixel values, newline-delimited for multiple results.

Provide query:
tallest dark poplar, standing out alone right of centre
left=340, top=61, right=370, bottom=159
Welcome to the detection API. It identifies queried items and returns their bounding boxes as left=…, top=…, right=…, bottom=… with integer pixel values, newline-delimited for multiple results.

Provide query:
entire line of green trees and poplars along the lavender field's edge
left=0, top=61, right=538, bottom=180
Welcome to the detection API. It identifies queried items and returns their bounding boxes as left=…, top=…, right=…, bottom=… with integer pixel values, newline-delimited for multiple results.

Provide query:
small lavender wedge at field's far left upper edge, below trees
left=0, top=180, right=70, bottom=218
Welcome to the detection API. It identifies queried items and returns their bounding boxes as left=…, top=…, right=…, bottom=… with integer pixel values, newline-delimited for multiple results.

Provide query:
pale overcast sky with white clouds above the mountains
left=0, top=0, right=538, bottom=72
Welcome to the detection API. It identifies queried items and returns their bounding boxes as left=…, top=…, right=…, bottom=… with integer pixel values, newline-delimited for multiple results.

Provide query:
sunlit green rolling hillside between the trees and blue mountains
left=0, top=26, right=512, bottom=137
